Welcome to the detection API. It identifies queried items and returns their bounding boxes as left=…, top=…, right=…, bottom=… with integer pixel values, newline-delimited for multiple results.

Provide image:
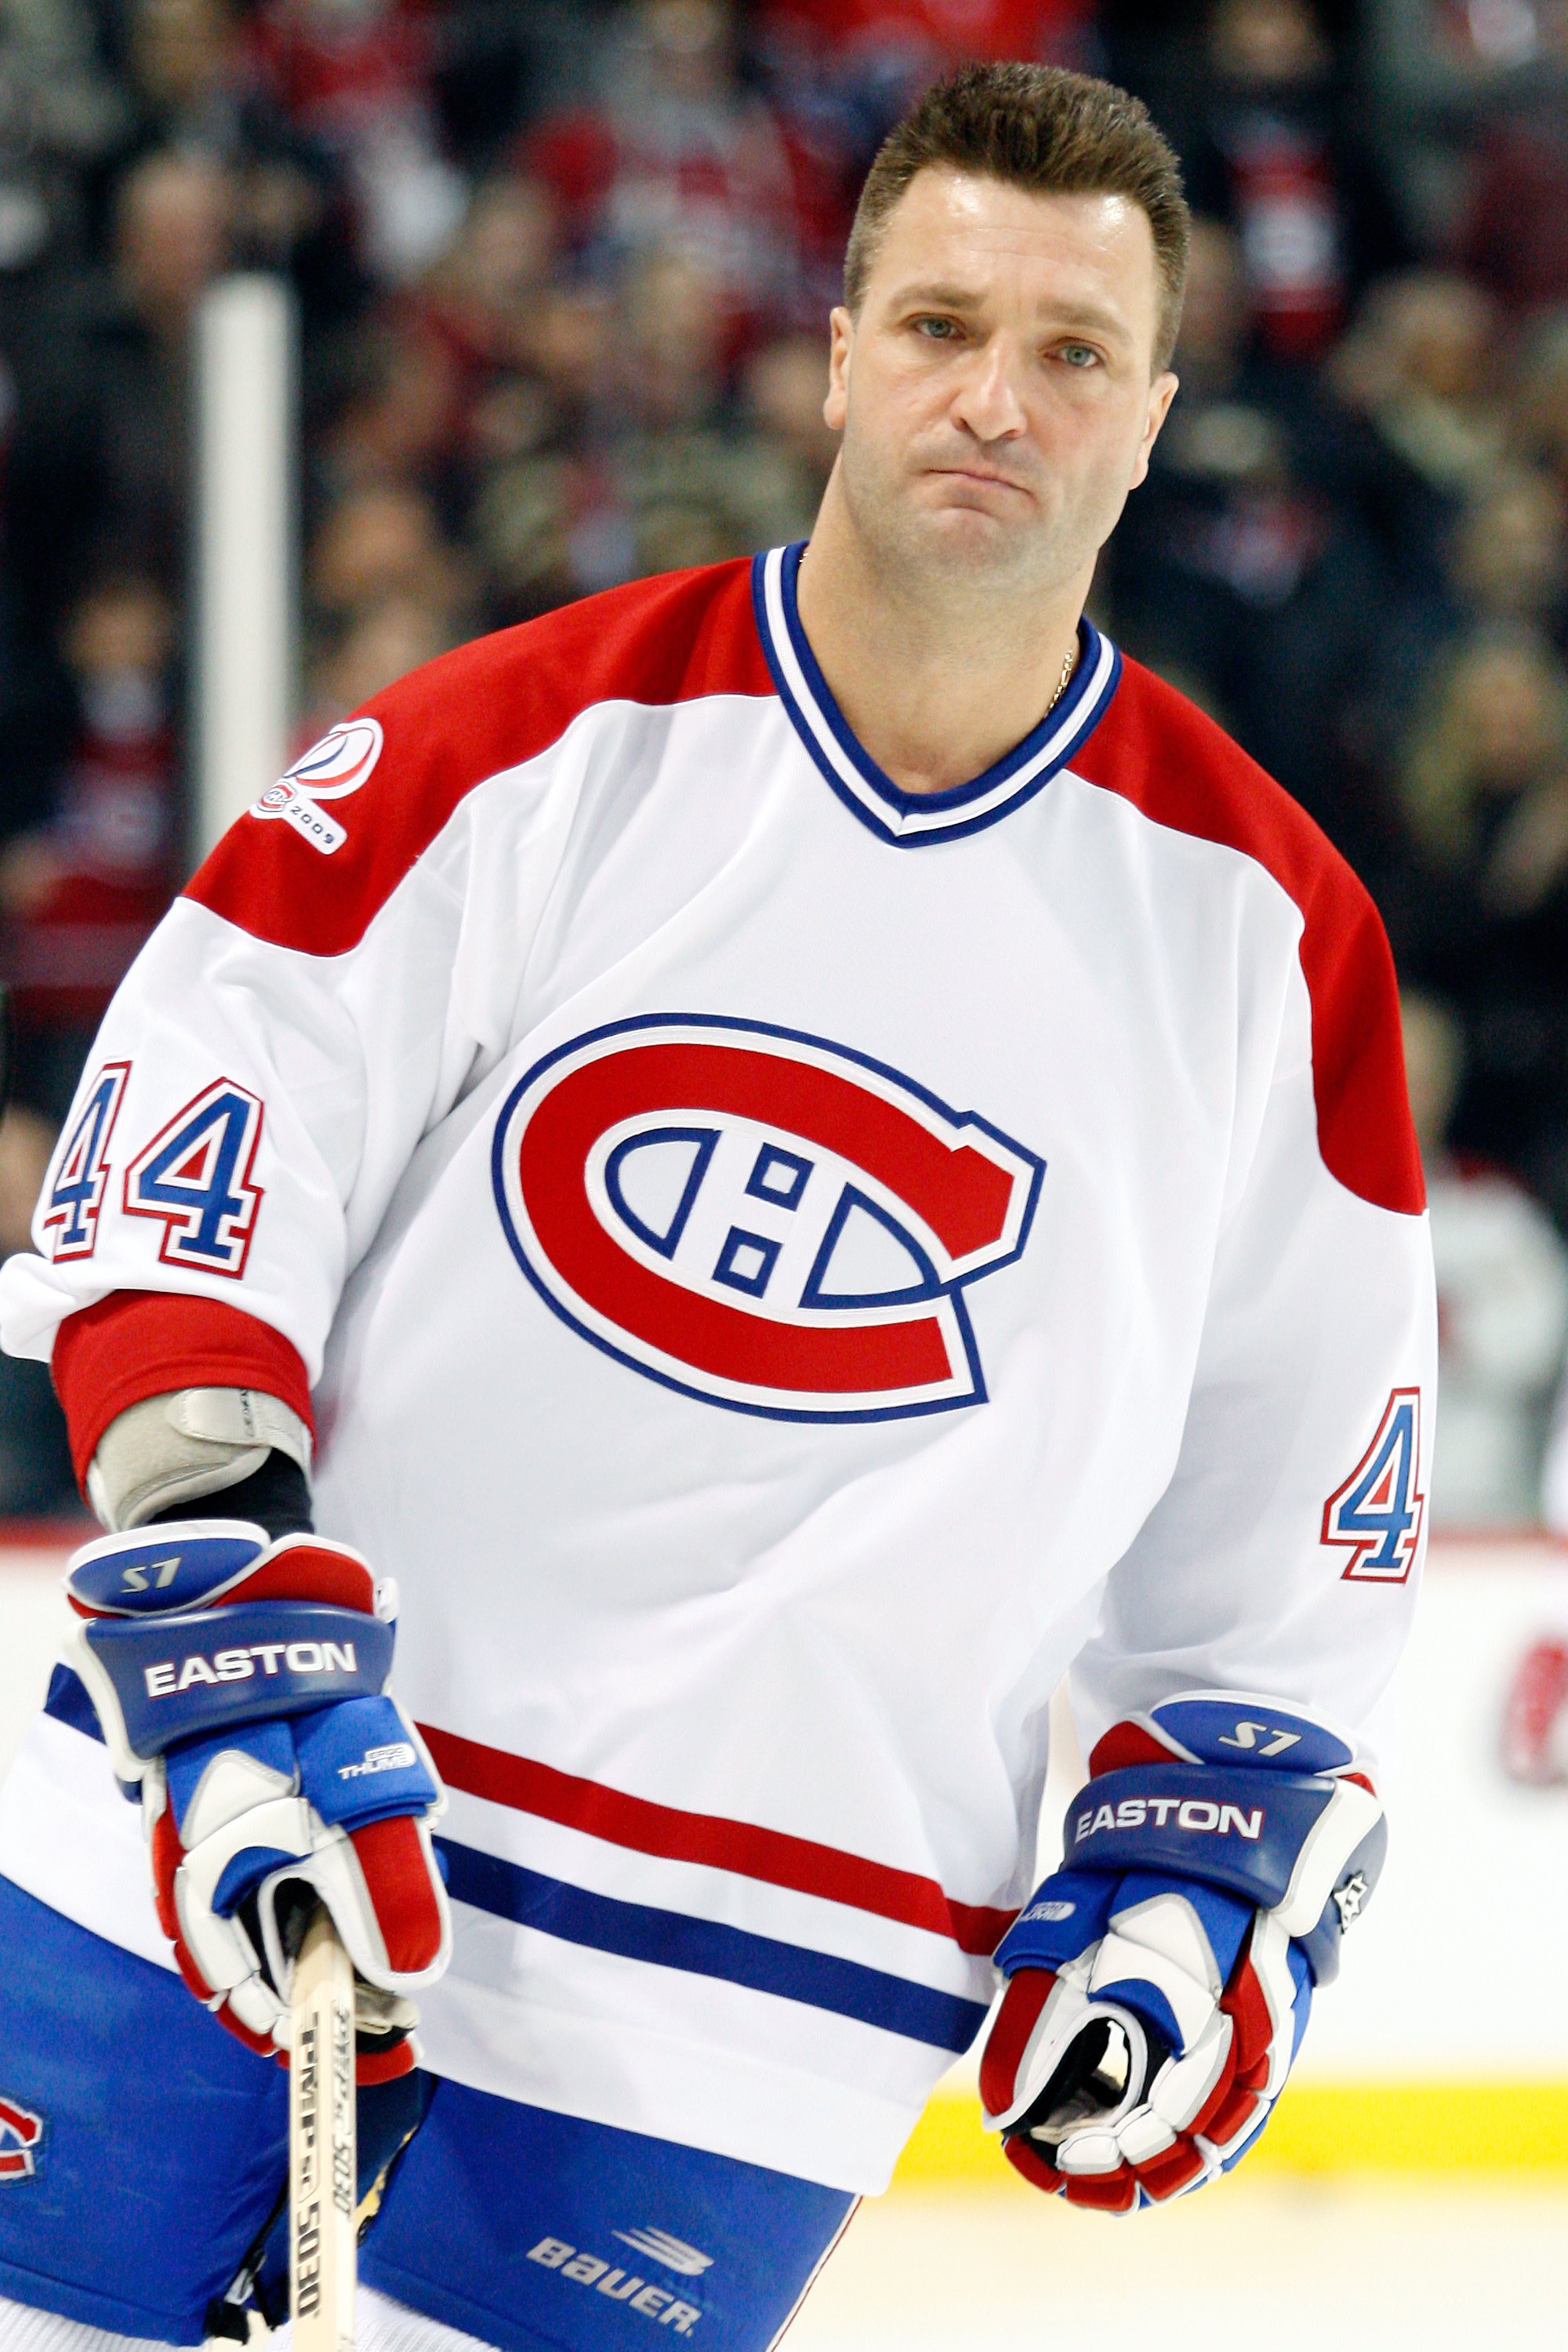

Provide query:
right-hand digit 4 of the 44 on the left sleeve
left=125, top=1077, right=261, bottom=1279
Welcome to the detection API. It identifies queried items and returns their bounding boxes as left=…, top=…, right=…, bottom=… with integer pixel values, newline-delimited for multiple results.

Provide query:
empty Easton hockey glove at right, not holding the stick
left=980, top=1691, right=1387, bottom=2213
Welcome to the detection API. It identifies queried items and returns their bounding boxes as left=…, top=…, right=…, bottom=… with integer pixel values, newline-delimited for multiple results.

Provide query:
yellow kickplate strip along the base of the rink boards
left=893, top=2082, right=1568, bottom=2194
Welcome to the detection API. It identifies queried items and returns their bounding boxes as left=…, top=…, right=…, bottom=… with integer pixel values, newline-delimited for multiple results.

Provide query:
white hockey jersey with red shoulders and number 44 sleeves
left=0, top=550, right=1434, bottom=2190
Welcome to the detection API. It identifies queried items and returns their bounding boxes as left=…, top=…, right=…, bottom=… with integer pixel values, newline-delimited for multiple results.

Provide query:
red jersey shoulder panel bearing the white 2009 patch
left=186, top=557, right=776, bottom=955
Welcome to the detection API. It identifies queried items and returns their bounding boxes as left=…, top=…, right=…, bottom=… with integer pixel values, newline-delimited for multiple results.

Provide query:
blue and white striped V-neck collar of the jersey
left=753, top=539, right=1121, bottom=849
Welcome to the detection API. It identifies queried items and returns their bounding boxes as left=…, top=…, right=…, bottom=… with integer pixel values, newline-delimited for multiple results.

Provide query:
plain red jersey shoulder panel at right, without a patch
left=1072, top=661, right=1427, bottom=1216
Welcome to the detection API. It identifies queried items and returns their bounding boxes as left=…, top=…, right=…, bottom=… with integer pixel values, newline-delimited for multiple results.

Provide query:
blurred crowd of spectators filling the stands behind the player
left=0, top=0, right=1568, bottom=1526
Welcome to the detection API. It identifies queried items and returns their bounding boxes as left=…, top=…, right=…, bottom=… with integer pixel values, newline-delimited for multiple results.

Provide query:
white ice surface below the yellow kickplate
left=785, top=2173, right=1568, bottom=2352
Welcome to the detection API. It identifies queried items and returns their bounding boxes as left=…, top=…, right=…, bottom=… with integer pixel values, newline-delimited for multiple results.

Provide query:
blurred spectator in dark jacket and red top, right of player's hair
left=1185, top=0, right=1408, bottom=362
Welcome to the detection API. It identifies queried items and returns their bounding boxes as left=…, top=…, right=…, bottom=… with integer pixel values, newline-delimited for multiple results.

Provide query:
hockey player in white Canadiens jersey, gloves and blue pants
left=0, top=50, right=1432, bottom=2352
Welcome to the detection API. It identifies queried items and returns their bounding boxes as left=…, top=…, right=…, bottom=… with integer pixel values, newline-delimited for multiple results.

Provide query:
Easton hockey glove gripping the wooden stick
left=66, top=1519, right=452, bottom=2084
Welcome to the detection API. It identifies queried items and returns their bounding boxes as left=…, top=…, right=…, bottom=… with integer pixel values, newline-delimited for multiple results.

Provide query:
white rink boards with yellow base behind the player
left=0, top=1529, right=1568, bottom=2190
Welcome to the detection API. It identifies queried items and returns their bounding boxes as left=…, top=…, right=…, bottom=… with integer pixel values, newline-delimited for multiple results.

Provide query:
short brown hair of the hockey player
left=844, top=64, right=1192, bottom=369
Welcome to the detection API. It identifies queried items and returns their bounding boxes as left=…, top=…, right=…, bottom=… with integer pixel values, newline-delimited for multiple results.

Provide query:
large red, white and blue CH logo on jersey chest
left=494, top=1016, right=1044, bottom=1421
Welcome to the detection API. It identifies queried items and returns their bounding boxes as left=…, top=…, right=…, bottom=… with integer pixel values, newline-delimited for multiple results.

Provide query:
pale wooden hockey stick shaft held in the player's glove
left=289, top=1910, right=355, bottom=2352
